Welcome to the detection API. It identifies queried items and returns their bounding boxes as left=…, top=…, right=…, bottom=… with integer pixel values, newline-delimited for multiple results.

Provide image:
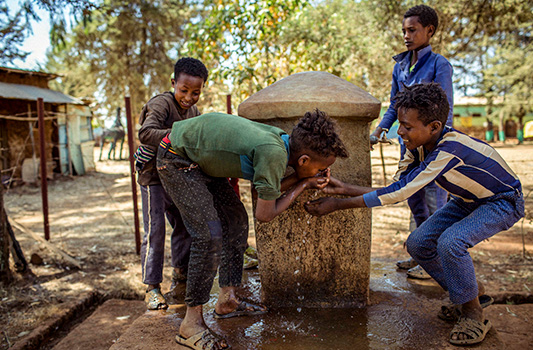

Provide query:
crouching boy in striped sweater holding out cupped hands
left=306, top=83, right=524, bottom=345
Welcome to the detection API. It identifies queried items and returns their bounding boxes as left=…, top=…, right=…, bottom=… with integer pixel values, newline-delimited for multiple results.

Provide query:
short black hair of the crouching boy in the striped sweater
left=394, top=83, right=450, bottom=125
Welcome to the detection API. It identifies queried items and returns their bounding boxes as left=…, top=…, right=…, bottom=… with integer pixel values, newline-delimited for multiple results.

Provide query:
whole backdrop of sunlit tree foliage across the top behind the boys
left=4, top=0, right=533, bottom=124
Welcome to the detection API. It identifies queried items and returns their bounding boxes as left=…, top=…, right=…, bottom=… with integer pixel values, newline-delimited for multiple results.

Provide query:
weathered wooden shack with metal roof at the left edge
left=0, top=67, right=94, bottom=184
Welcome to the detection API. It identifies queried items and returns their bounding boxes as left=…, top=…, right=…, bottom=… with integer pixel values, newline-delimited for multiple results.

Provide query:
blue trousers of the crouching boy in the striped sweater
left=406, top=190, right=524, bottom=304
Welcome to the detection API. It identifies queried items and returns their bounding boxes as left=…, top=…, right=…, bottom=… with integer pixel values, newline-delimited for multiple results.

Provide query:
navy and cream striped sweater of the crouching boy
left=363, top=127, right=522, bottom=207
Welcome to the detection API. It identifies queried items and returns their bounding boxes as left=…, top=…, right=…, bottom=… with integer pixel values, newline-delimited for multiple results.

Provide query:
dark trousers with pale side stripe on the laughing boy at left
left=141, top=185, right=191, bottom=284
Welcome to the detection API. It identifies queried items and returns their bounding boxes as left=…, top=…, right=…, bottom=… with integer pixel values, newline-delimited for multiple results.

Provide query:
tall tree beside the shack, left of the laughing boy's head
left=50, top=0, right=192, bottom=121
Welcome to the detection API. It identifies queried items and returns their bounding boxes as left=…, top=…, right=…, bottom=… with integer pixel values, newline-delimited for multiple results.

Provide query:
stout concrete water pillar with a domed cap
left=238, top=72, right=381, bottom=307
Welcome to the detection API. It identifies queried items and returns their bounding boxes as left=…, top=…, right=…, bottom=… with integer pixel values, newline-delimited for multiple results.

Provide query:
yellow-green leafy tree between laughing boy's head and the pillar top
left=184, top=0, right=307, bottom=110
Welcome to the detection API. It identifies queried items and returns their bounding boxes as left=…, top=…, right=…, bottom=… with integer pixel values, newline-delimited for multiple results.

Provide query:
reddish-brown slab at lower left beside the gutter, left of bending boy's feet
left=52, top=299, right=146, bottom=350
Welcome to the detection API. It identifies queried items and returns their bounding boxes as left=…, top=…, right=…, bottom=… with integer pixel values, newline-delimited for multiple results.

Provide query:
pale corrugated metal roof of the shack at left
left=0, top=82, right=83, bottom=105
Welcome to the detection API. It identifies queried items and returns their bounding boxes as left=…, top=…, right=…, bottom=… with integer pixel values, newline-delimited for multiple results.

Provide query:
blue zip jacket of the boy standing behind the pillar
left=379, top=46, right=453, bottom=129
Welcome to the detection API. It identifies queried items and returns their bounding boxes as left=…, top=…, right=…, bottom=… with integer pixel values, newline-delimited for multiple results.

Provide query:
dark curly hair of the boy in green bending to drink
left=290, top=109, right=348, bottom=158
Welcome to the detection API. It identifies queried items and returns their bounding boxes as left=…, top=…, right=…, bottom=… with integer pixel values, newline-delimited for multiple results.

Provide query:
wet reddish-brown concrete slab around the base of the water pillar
left=107, top=261, right=512, bottom=350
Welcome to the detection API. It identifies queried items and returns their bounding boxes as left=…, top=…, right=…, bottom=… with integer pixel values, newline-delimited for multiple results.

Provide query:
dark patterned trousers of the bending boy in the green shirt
left=157, top=146, right=248, bottom=307
